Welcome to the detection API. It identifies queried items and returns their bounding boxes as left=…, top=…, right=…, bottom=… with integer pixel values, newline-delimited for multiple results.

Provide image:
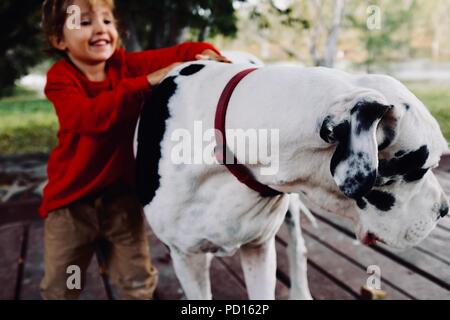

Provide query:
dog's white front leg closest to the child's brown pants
left=170, top=248, right=212, bottom=300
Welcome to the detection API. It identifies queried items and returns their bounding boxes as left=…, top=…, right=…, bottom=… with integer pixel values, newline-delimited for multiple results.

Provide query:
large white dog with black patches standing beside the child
left=137, top=61, right=448, bottom=299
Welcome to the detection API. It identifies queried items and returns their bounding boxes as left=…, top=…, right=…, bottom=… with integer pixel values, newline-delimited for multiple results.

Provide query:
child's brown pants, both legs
left=41, top=187, right=158, bottom=299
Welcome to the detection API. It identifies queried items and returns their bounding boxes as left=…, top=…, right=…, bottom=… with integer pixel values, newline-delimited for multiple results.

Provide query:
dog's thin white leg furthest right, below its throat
left=285, top=195, right=312, bottom=300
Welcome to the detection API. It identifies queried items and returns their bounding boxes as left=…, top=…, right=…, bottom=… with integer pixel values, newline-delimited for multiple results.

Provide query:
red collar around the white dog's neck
left=214, top=68, right=281, bottom=197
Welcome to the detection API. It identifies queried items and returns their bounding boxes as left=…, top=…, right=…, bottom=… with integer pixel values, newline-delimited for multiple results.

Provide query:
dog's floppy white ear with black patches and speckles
left=320, top=101, right=392, bottom=199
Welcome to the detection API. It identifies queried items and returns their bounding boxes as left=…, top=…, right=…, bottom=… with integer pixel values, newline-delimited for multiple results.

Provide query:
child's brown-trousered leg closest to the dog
left=101, top=194, right=158, bottom=299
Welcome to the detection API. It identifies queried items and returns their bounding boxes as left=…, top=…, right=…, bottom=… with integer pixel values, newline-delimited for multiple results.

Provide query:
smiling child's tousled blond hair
left=42, top=0, right=120, bottom=53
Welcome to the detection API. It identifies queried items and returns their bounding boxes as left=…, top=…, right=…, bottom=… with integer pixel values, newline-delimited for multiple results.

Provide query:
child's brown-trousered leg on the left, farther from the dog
left=41, top=204, right=98, bottom=300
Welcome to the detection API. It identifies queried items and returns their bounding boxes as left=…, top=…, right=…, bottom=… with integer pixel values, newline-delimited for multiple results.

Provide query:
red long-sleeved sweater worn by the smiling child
left=39, top=43, right=218, bottom=217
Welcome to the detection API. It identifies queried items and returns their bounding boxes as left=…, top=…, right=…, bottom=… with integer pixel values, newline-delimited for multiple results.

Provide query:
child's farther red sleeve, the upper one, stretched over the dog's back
left=126, top=42, right=220, bottom=77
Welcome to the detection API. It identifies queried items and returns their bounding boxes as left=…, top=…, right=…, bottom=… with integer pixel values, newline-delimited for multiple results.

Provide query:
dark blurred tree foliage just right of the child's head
left=116, top=0, right=246, bottom=51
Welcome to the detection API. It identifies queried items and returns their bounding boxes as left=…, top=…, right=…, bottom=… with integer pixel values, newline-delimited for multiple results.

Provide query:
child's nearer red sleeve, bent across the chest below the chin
left=45, top=67, right=150, bottom=134
